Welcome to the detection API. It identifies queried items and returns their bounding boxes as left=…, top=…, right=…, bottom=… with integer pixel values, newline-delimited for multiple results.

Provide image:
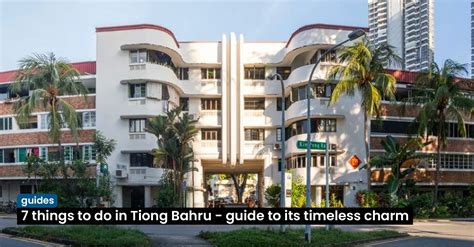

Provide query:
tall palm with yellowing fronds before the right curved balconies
left=328, top=41, right=401, bottom=189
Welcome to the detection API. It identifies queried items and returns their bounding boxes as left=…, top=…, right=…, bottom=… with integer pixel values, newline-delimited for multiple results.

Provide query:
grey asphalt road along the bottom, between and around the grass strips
left=0, top=217, right=474, bottom=247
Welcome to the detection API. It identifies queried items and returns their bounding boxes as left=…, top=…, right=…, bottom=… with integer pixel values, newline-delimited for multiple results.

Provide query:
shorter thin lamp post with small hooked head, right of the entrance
left=268, top=73, right=286, bottom=212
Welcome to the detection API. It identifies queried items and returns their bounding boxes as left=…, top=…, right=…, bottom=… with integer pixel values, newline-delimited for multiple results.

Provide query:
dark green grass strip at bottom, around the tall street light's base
left=199, top=228, right=405, bottom=246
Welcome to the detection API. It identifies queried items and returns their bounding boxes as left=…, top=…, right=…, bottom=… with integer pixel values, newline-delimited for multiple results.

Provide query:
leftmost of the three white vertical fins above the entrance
left=221, top=34, right=229, bottom=165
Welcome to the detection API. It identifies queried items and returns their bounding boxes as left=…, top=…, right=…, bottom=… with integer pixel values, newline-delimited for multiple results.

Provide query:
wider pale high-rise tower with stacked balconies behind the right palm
left=368, top=0, right=434, bottom=71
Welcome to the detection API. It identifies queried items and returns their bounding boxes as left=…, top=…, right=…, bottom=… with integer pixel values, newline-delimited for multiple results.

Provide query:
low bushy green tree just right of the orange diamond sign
left=370, top=136, right=429, bottom=205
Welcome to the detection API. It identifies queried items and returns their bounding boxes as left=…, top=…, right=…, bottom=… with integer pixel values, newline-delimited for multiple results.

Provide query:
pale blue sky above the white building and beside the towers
left=0, top=0, right=471, bottom=75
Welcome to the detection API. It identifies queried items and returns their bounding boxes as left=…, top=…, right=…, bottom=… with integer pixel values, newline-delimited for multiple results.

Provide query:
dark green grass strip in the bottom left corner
left=4, top=225, right=152, bottom=246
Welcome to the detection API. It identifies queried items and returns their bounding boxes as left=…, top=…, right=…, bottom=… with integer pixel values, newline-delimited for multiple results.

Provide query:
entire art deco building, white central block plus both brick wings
left=0, top=24, right=474, bottom=207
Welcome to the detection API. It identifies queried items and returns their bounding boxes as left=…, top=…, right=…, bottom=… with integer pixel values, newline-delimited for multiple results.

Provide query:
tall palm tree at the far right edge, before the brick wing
left=401, top=59, right=474, bottom=207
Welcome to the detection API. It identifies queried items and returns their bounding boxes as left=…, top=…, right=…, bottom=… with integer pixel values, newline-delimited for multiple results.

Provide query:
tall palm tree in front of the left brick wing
left=10, top=53, right=87, bottom=178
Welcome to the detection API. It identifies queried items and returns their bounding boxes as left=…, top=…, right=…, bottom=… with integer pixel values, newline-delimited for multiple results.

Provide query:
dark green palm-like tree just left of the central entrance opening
left=145, top=107, right=199, bottom=206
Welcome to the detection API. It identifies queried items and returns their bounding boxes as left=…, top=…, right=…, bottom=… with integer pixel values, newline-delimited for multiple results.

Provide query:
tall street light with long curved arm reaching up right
left=304, top=29, right=365, bottom=243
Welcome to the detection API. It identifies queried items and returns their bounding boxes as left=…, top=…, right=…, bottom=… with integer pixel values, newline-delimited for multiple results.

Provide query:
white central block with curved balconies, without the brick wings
left=96, top=24, right=367, bottom=207
